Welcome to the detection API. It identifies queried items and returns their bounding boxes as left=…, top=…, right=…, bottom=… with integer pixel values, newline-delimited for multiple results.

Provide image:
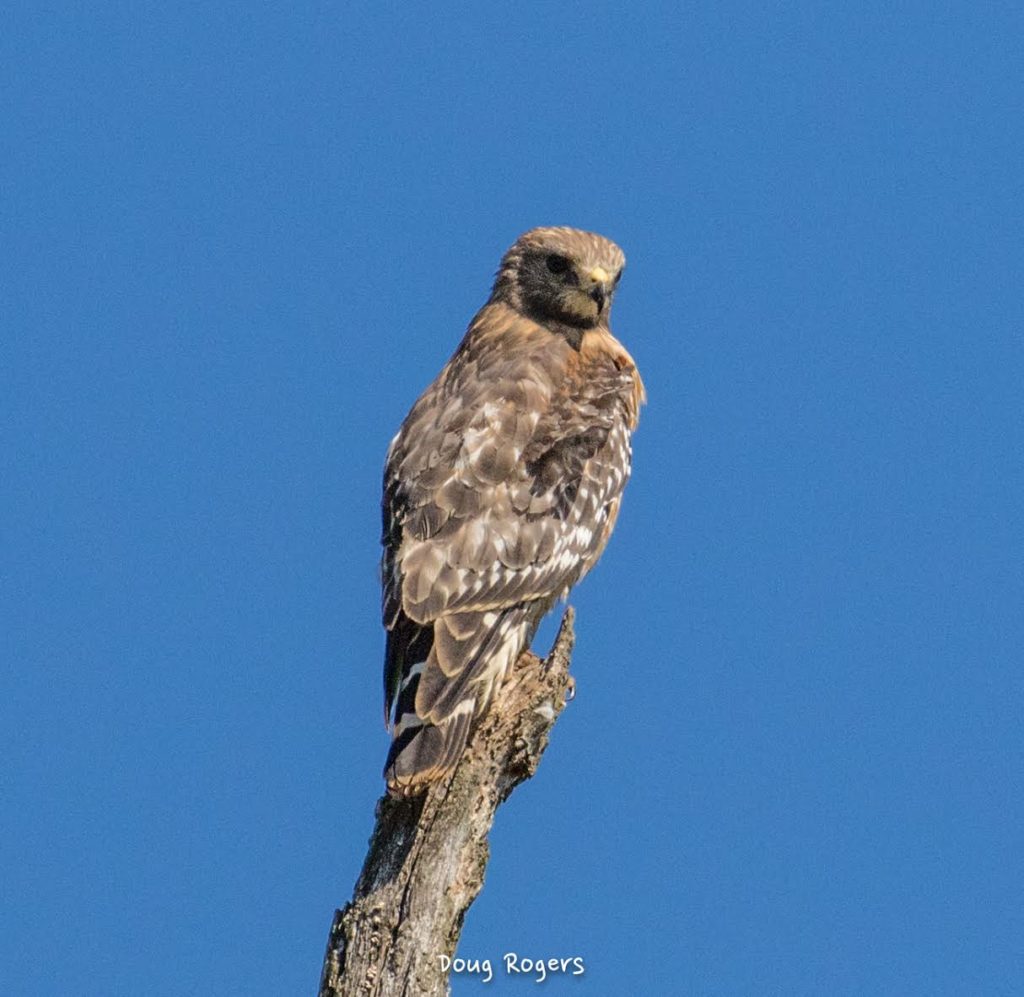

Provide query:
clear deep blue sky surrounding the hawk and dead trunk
left=0, top=2, right=1024, bottom=997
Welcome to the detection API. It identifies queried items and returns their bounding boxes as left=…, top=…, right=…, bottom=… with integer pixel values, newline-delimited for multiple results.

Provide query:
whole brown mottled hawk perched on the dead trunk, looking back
left=382, top=228, right=644, bottom=795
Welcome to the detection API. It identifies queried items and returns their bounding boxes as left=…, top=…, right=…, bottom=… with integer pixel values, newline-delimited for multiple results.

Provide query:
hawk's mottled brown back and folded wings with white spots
left=383, top=327, right=635, bottom=723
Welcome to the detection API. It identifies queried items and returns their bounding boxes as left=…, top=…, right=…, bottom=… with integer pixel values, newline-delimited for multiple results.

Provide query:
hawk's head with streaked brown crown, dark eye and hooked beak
left=490, top=228, right=626, bottom=329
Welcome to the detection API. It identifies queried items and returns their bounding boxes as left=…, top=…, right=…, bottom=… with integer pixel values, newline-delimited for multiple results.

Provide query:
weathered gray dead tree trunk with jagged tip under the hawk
left=319, top=608, right=573, bottom=997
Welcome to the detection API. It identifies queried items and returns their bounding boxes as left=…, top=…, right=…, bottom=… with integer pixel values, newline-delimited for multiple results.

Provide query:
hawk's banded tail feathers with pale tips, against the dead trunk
left=384, top=606, right=527, bottom=796
